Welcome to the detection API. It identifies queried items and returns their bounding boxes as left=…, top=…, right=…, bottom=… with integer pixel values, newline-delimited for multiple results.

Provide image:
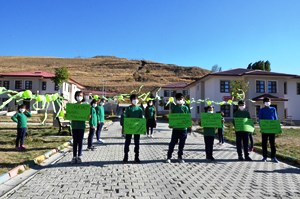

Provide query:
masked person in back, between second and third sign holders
left=145, top=100, right=156, bottom=137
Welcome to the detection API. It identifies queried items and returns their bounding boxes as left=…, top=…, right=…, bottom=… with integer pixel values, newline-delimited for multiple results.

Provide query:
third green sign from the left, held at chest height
left=169, top=113, right=192, bottom=129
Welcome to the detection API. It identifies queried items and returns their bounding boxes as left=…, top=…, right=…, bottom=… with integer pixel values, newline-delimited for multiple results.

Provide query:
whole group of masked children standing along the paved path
left=11, top=91, right=278, bottom=163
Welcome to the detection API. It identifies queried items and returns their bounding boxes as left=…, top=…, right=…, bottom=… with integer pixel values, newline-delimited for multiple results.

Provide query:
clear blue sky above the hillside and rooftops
left=0, top=0, right=300, bottom=75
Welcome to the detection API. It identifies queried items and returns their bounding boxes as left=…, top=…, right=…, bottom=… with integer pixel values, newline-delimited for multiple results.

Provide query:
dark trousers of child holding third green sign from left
left=167, top=129, right=187, bottom=159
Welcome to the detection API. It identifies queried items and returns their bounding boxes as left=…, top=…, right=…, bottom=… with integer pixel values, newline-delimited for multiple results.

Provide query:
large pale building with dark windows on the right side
left=154, top=68, right=300, bottom=124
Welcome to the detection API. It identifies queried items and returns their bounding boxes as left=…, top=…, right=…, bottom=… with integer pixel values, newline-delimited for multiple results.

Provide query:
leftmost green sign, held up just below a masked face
left=65, top=103, right=91, bottom=121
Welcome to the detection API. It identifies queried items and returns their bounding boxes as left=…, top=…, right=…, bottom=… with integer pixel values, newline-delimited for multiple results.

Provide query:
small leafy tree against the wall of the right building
left=230, top=80, right=249, bottom=101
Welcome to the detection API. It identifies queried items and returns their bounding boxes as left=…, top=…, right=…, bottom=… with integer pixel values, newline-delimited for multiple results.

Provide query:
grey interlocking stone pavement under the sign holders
left=5, top=123, right=300, bottom=199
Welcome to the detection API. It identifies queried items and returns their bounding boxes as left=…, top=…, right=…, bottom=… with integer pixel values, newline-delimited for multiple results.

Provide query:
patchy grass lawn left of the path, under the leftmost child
left=0, top=126, right=71, bottom=174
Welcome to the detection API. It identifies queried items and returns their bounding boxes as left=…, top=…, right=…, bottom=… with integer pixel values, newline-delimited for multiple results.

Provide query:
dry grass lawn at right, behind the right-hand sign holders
left=199, top=124, right=300, bottom=165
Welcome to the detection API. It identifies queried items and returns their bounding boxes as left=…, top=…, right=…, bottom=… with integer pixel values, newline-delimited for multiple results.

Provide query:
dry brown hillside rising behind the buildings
left=0, top=56, right=209, bottom=93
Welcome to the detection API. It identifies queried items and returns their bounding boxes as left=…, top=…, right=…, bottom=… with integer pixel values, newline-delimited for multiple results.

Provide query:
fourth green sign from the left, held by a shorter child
left=201, top=113, right=222, bottom=128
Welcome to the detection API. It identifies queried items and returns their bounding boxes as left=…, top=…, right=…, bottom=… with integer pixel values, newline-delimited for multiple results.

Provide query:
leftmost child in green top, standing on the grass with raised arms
left=11, top=104, right=31, bottom=151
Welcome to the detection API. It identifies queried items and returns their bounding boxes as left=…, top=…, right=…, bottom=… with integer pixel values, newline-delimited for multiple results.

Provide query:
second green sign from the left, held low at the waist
left=124, top=118, right=146, bottom=134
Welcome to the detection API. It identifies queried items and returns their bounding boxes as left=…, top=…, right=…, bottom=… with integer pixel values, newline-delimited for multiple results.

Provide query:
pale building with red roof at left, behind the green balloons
left=0, top=71, right=84, bottom=111
